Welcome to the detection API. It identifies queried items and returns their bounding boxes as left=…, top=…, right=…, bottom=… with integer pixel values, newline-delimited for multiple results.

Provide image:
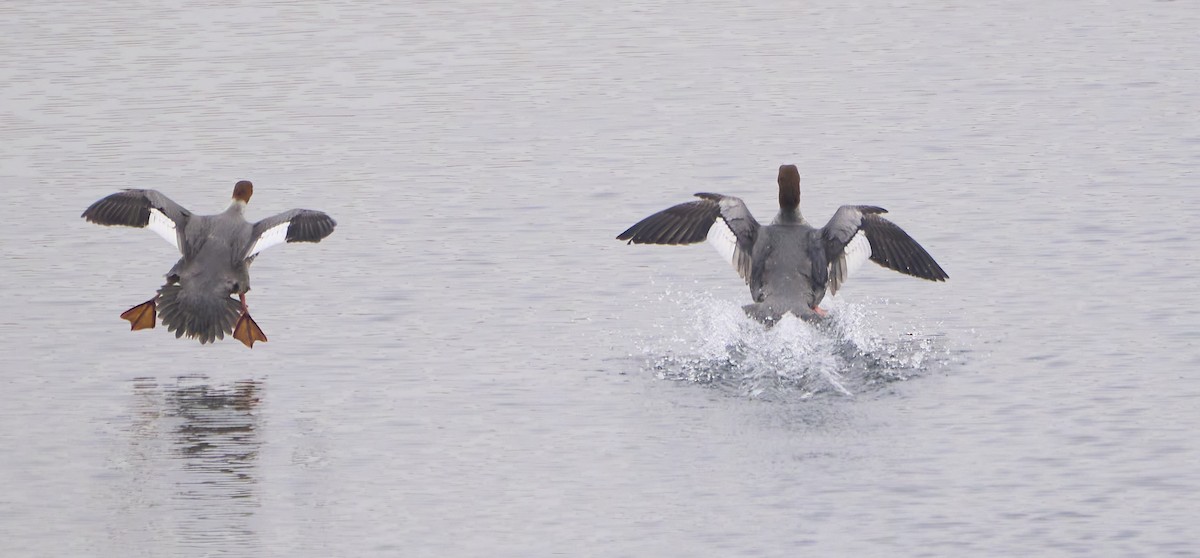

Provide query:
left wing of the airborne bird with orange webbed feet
left=80, top=190, right=192, bottom=250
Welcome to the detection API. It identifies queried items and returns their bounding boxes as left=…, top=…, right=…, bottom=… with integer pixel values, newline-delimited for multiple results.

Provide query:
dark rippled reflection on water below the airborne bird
left=133, top=376, right=263, bottom=551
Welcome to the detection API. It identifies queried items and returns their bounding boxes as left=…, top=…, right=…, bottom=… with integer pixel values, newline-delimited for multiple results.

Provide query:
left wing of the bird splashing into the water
left=617, top=193, right=758, bottom=281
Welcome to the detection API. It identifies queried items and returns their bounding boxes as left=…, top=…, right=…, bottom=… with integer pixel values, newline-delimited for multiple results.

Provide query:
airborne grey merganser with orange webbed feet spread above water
left=82, top=180, right=337, bottom=348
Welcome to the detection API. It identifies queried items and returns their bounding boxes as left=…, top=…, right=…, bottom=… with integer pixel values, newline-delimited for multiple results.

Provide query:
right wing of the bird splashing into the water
left=821, top=205, right=949, bottom=294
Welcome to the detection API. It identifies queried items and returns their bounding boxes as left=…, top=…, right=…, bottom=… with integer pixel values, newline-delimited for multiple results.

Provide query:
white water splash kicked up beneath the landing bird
left=641, top=290, right=950, bottom=398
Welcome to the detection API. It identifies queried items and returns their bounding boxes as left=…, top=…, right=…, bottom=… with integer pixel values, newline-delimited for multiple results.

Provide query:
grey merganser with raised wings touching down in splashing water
left=617, top=164, right=949, bottom=324
